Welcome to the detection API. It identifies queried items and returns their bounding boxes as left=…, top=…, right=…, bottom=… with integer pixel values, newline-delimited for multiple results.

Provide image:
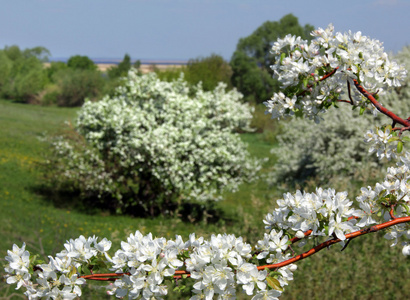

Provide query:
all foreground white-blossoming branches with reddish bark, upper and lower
left=6, top=26, right=410, bottom=300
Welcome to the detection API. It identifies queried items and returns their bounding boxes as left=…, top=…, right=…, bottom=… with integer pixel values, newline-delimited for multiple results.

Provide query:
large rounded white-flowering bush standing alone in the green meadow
left=44, top=71, right=259, bottom=215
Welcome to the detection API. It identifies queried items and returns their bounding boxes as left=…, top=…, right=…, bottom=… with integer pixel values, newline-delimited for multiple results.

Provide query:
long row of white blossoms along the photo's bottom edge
left=5, top=231, right=296, bottom=300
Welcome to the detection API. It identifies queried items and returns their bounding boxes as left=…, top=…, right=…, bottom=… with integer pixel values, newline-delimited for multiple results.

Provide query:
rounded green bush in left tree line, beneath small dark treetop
left=55, top=69, right=104, bottom=107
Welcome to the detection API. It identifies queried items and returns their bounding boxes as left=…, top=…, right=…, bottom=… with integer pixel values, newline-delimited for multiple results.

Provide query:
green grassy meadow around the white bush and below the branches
left=0, top=100, right=410, bottom=299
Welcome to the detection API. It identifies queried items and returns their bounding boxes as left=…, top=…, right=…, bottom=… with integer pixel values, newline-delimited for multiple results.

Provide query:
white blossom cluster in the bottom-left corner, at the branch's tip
left=5, top=236, right=111, bottom=299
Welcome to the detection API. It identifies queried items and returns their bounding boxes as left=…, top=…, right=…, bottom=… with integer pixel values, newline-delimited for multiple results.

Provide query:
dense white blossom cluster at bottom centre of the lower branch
left=107, top=231, right=295, bottom=299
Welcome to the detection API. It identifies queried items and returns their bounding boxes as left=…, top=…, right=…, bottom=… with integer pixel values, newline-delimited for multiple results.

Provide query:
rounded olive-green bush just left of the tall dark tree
left=185, top=54, right=232, bottom=91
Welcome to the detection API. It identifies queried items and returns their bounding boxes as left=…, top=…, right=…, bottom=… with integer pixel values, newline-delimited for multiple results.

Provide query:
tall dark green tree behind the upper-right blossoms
left=230, top=14, right=314, bottom=103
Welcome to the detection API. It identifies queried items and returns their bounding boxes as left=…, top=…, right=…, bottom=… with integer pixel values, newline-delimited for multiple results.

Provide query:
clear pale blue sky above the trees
left=0, top=0, right=410, bottom=60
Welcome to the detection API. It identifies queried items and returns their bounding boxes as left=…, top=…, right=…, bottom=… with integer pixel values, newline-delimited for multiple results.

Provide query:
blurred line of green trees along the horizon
left=0, top=14, right=313, bottom=106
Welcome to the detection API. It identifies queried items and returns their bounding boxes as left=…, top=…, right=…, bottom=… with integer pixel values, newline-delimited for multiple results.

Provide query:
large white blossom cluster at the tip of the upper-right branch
left=265, top=25, right=406, bottom=122
